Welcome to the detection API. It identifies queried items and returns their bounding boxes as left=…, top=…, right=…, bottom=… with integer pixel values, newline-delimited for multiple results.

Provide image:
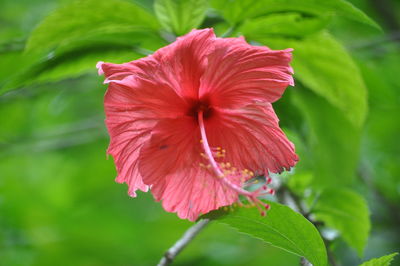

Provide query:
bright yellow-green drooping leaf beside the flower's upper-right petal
left=256, top=32, right=367, bottom=126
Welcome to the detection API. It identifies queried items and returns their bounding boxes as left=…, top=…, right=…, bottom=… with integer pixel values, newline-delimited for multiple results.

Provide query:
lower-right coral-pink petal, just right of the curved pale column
left=205, top=103, right=298, bottom=174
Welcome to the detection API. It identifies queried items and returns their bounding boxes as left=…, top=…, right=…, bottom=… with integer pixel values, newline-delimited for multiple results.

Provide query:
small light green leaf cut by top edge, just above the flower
left=154, top=0, right=208, bottom=35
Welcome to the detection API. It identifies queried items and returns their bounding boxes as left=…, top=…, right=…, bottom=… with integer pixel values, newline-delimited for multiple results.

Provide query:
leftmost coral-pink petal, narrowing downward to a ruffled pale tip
left=104, top=70, right=191, bottom=196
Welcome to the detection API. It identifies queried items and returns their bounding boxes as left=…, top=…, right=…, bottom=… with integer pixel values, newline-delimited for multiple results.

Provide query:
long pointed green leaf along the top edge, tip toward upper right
left=211, top=0, right=380, bottom=29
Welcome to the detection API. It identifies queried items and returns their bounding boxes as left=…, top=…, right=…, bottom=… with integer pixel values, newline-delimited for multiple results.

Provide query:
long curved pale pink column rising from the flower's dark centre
left=197, top=111, right=254, bottom=198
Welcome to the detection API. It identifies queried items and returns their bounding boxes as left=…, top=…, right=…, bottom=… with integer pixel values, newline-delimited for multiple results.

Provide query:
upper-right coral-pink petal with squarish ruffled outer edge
left=200, top=38, right=294, bottom=108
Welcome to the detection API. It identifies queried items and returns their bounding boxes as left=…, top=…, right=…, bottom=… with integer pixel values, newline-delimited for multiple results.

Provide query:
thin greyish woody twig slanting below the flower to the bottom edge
left=158, top=219, right=210, bottom=266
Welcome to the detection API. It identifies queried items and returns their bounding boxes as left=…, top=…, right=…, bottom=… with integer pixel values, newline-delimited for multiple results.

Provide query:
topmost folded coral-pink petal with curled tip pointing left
left=97, top=29, right=215, bottom=98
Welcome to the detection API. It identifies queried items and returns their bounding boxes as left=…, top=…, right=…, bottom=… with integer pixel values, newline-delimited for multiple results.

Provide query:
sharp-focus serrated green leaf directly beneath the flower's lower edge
left=204, top=202, right=327, bottom=266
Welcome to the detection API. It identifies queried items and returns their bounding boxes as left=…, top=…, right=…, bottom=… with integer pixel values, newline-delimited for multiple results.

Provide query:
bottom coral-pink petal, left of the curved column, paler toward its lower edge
left=139, top=117, right=240, bottom=221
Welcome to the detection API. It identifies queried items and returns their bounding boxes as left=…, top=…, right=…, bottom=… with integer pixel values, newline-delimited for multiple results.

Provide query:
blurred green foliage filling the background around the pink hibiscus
left=0, top=0, right=400, bottom=266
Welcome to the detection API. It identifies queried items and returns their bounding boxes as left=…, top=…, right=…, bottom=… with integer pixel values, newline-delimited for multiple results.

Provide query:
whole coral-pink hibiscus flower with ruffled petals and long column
left=98, top=29, right=298, bottom=221
